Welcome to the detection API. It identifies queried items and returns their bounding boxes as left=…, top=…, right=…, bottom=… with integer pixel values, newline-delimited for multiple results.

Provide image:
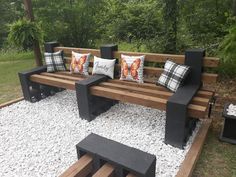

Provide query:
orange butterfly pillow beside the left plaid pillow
left=70, top=51, right=91, bottom=75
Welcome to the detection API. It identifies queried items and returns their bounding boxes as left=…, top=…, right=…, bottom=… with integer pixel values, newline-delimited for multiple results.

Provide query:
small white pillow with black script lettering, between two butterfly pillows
left=93, top=56, right=116, bottom=79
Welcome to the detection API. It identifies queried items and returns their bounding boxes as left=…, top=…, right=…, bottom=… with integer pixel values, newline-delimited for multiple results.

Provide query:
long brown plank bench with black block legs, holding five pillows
left=19, top=43, right=219, bottom=147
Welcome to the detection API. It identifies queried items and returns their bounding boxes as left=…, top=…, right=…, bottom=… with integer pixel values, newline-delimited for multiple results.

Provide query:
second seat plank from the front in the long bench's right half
left=99, top=82, right=209, bottom=106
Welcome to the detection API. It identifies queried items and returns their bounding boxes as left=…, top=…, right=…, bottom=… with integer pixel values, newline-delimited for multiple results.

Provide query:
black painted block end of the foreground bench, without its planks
left=76, top=134, right=156, bottom=177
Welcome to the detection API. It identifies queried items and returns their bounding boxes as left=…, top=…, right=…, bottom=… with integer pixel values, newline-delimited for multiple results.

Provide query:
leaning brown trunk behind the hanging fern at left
left=23, top=0, right=43, bottom=66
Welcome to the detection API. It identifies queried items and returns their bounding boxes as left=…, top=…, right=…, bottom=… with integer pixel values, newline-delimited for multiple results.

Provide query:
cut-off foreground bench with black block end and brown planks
left=60, top=134, right=156, bottom=177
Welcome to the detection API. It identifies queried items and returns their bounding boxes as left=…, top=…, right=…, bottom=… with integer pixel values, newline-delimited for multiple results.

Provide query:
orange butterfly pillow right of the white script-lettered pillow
left=120, top=54, right=145, bottom=83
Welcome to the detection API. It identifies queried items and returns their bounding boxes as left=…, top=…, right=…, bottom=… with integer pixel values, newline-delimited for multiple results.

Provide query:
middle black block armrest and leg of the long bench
left=75, top=75, right=114, bottom=121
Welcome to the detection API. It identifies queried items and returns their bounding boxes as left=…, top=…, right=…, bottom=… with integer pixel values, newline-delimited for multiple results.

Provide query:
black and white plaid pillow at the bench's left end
left=44, top=51, right=66, bottom=72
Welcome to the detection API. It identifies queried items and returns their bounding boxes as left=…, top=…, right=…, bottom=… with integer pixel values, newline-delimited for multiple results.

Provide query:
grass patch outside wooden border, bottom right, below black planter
left=193, top=124, right=236, bottom=177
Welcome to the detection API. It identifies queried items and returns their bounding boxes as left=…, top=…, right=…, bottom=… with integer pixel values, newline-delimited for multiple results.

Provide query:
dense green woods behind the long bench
left=0, top=0, right=236, bottom=74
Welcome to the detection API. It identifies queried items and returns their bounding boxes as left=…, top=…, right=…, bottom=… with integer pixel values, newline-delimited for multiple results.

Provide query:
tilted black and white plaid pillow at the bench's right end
left=157, top=60, right=190, bottom=92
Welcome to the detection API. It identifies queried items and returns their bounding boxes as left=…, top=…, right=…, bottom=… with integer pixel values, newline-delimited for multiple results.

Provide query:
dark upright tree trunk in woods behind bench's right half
left=164, top=0, right=177, bottom=53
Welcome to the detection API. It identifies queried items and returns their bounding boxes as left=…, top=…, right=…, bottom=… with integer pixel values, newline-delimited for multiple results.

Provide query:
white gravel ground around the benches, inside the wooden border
left=0, top=91, right=200, bottom=177
